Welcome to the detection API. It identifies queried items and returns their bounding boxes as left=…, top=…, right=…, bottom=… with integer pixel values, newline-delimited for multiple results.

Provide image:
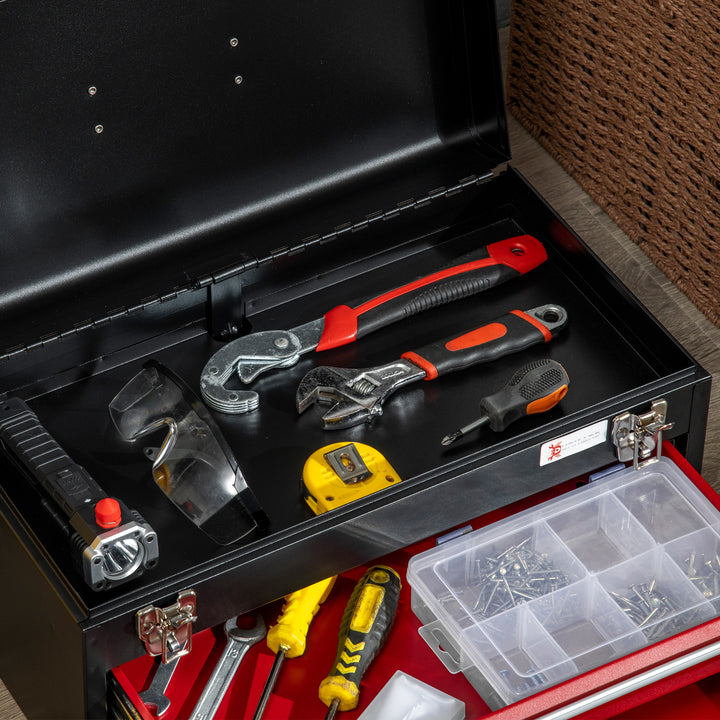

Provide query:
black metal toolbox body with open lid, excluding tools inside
left=0, top=0, right=710, bottom=717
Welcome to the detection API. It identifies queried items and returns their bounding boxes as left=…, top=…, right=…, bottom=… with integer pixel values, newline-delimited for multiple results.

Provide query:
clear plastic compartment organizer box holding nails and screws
left=407, top=458, right=720, bottom=709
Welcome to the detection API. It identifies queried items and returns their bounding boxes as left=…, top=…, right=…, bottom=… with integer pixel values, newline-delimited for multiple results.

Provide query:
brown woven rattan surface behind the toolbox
left=507, top=0, right=720, bottom=327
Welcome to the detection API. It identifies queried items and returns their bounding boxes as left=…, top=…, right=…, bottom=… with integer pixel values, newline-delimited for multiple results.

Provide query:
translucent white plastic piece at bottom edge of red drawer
left=358, top=670, right=465, bottom=720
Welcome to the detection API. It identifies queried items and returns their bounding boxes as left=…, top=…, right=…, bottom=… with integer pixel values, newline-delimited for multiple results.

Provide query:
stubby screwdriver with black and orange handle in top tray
left=441, top=359, right=570, bottom=445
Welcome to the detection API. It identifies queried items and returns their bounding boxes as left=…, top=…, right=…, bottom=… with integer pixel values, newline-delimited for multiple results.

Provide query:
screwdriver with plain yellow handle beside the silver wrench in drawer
left=253, top=575, right=336, bottom=720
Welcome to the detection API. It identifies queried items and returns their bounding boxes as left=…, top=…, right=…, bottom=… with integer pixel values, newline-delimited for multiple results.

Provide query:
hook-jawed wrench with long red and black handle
left=200, top=235, right=547, bottom=414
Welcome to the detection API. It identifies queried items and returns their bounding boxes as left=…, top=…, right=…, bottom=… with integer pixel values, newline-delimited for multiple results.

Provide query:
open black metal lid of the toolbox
left=0, top=0, right=508, bottom=355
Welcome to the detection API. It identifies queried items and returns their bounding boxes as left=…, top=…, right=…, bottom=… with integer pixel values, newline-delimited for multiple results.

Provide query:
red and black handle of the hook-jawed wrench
left=317, top=235, right=547, bottom=352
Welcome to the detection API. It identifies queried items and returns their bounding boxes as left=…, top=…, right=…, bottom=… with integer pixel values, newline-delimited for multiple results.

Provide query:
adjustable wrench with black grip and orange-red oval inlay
left=295, top=305, right=567, bottom=430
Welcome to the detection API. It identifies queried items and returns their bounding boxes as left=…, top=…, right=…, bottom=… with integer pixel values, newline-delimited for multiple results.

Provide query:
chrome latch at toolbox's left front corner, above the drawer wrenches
left=135, top=590, right=197, bottom=663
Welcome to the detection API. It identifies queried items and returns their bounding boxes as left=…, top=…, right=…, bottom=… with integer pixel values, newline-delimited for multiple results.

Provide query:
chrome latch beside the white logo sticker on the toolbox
left=612, top=400, right=675, bottom=470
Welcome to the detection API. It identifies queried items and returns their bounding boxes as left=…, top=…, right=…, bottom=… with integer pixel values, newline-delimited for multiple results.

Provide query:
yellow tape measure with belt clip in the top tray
left=303, top=442, right=400, bottom=515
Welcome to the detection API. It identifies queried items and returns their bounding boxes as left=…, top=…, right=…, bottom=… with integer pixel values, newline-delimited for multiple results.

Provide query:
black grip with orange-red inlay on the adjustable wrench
left=402, top=310, right=553, bottom=380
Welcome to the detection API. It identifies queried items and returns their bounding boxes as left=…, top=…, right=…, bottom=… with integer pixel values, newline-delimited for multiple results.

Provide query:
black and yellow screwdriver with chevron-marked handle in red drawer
left=318, top=565, right=401, bottom=720
